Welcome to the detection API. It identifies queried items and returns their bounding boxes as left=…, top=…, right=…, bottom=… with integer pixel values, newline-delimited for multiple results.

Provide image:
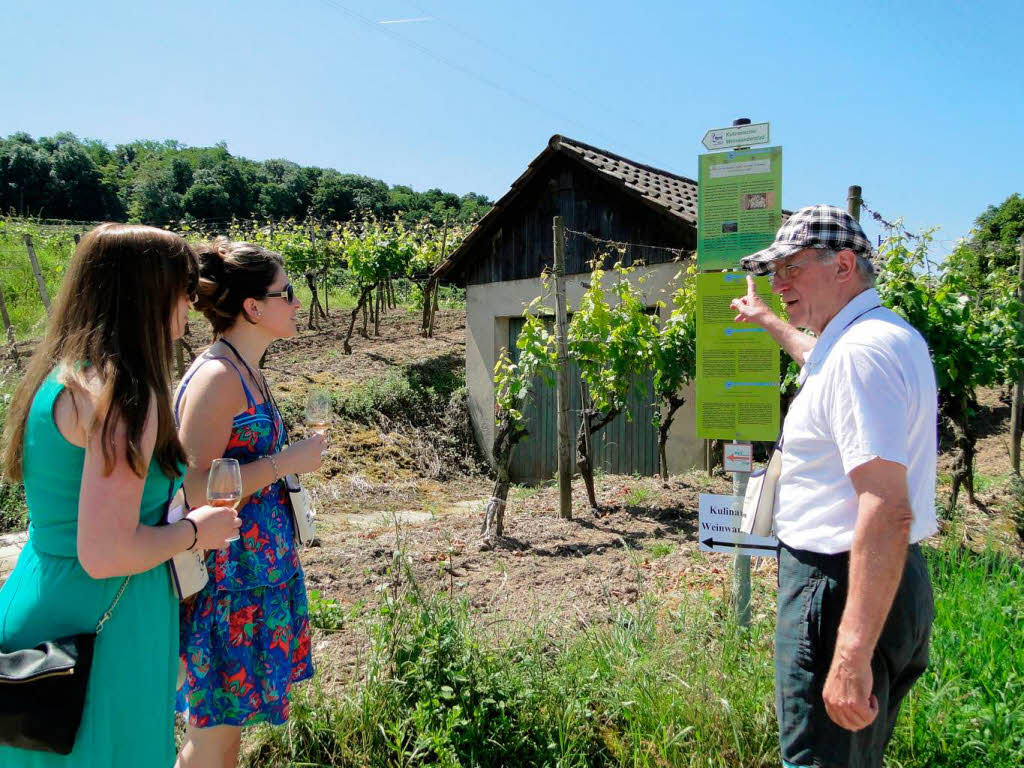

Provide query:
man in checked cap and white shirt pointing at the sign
left=732, top=205, right=937, bottom=768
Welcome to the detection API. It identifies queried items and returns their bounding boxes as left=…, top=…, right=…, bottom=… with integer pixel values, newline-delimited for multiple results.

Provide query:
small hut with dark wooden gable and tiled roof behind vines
left=435, top=135, right=701, bottom=480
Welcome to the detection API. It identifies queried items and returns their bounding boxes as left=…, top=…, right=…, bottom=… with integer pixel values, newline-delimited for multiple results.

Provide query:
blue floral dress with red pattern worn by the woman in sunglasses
left=175, top=356, right=313, bottom=728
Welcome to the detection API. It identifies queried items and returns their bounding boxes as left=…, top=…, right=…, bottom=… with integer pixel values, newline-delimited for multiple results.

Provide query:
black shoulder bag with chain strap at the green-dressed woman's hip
left=0, top=577, right=131, bottom=755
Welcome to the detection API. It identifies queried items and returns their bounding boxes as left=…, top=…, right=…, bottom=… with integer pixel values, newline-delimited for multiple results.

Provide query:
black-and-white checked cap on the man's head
left=739, top=205, right=871, bottom=274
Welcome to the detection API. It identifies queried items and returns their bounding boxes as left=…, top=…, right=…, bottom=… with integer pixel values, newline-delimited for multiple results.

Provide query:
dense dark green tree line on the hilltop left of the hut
left=0, top=132, right=492, bottom=225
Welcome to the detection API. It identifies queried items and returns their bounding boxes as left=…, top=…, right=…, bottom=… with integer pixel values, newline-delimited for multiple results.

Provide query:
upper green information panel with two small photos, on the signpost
left=697, top=146, right=782, bottom=269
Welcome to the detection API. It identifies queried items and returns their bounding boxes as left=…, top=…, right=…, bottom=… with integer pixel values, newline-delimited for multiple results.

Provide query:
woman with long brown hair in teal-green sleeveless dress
left=0, top=224, right=239, bottom=768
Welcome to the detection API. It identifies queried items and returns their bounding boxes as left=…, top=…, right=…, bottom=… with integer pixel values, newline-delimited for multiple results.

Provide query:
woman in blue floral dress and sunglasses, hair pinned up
left=175, top=240, right=327, bottom=768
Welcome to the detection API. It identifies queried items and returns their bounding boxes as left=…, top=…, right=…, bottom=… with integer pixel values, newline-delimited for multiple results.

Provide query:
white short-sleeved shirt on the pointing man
left=775, top=289, right=938, bottom=554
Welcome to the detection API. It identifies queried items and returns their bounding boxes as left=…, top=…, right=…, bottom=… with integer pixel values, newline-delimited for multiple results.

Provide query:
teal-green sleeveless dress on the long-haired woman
left=0, top=374, right=181, bottom=768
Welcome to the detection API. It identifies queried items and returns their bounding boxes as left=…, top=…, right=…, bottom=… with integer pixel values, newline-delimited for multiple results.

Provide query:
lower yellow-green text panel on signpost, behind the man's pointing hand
left=696, top=272, right=780, bottom=440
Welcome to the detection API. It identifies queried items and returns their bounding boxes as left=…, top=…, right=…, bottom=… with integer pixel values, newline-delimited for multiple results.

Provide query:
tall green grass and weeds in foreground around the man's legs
left=241, top=545, right=1024, bottom=768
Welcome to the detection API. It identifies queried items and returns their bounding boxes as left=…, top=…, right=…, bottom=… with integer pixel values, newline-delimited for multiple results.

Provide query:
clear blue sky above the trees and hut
left=0, top=0, right=1024, bottom=253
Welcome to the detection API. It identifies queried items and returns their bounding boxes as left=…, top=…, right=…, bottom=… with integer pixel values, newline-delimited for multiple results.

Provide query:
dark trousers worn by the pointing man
left=775, top=544, right=935, bottom=768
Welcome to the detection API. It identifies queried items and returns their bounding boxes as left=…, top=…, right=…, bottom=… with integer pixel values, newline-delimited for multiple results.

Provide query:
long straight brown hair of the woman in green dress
left=3, top=224, right=198, bottom=480
